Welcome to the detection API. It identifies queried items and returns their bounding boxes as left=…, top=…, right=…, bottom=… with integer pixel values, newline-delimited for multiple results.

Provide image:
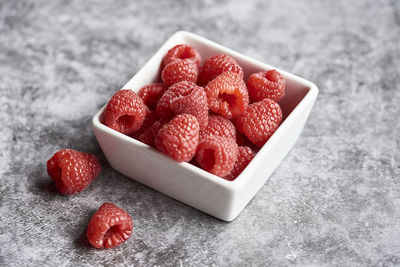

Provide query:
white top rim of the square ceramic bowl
left=91, top=31, right=318, bottom=191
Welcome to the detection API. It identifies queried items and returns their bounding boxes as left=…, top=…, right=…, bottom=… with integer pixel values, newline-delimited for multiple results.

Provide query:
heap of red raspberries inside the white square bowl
left=103, top=44, right=285, bottom=181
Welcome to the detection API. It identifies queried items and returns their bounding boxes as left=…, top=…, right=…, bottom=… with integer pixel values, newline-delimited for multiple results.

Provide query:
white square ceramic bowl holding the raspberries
left=91, top=31, right=318, bottom=221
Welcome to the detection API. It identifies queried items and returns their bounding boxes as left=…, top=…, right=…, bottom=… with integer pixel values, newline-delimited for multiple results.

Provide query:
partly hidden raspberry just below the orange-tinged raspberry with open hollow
left=200, top=115, right=236, bottom=140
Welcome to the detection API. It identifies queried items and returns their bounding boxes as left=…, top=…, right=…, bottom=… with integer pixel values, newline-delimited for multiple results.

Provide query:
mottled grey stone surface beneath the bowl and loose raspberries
left=0, top=0, right=400, bottom=266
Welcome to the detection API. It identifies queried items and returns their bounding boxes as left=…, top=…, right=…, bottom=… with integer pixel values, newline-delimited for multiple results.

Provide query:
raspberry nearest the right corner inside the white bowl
left=247, top=70, right=285, bottom=102
